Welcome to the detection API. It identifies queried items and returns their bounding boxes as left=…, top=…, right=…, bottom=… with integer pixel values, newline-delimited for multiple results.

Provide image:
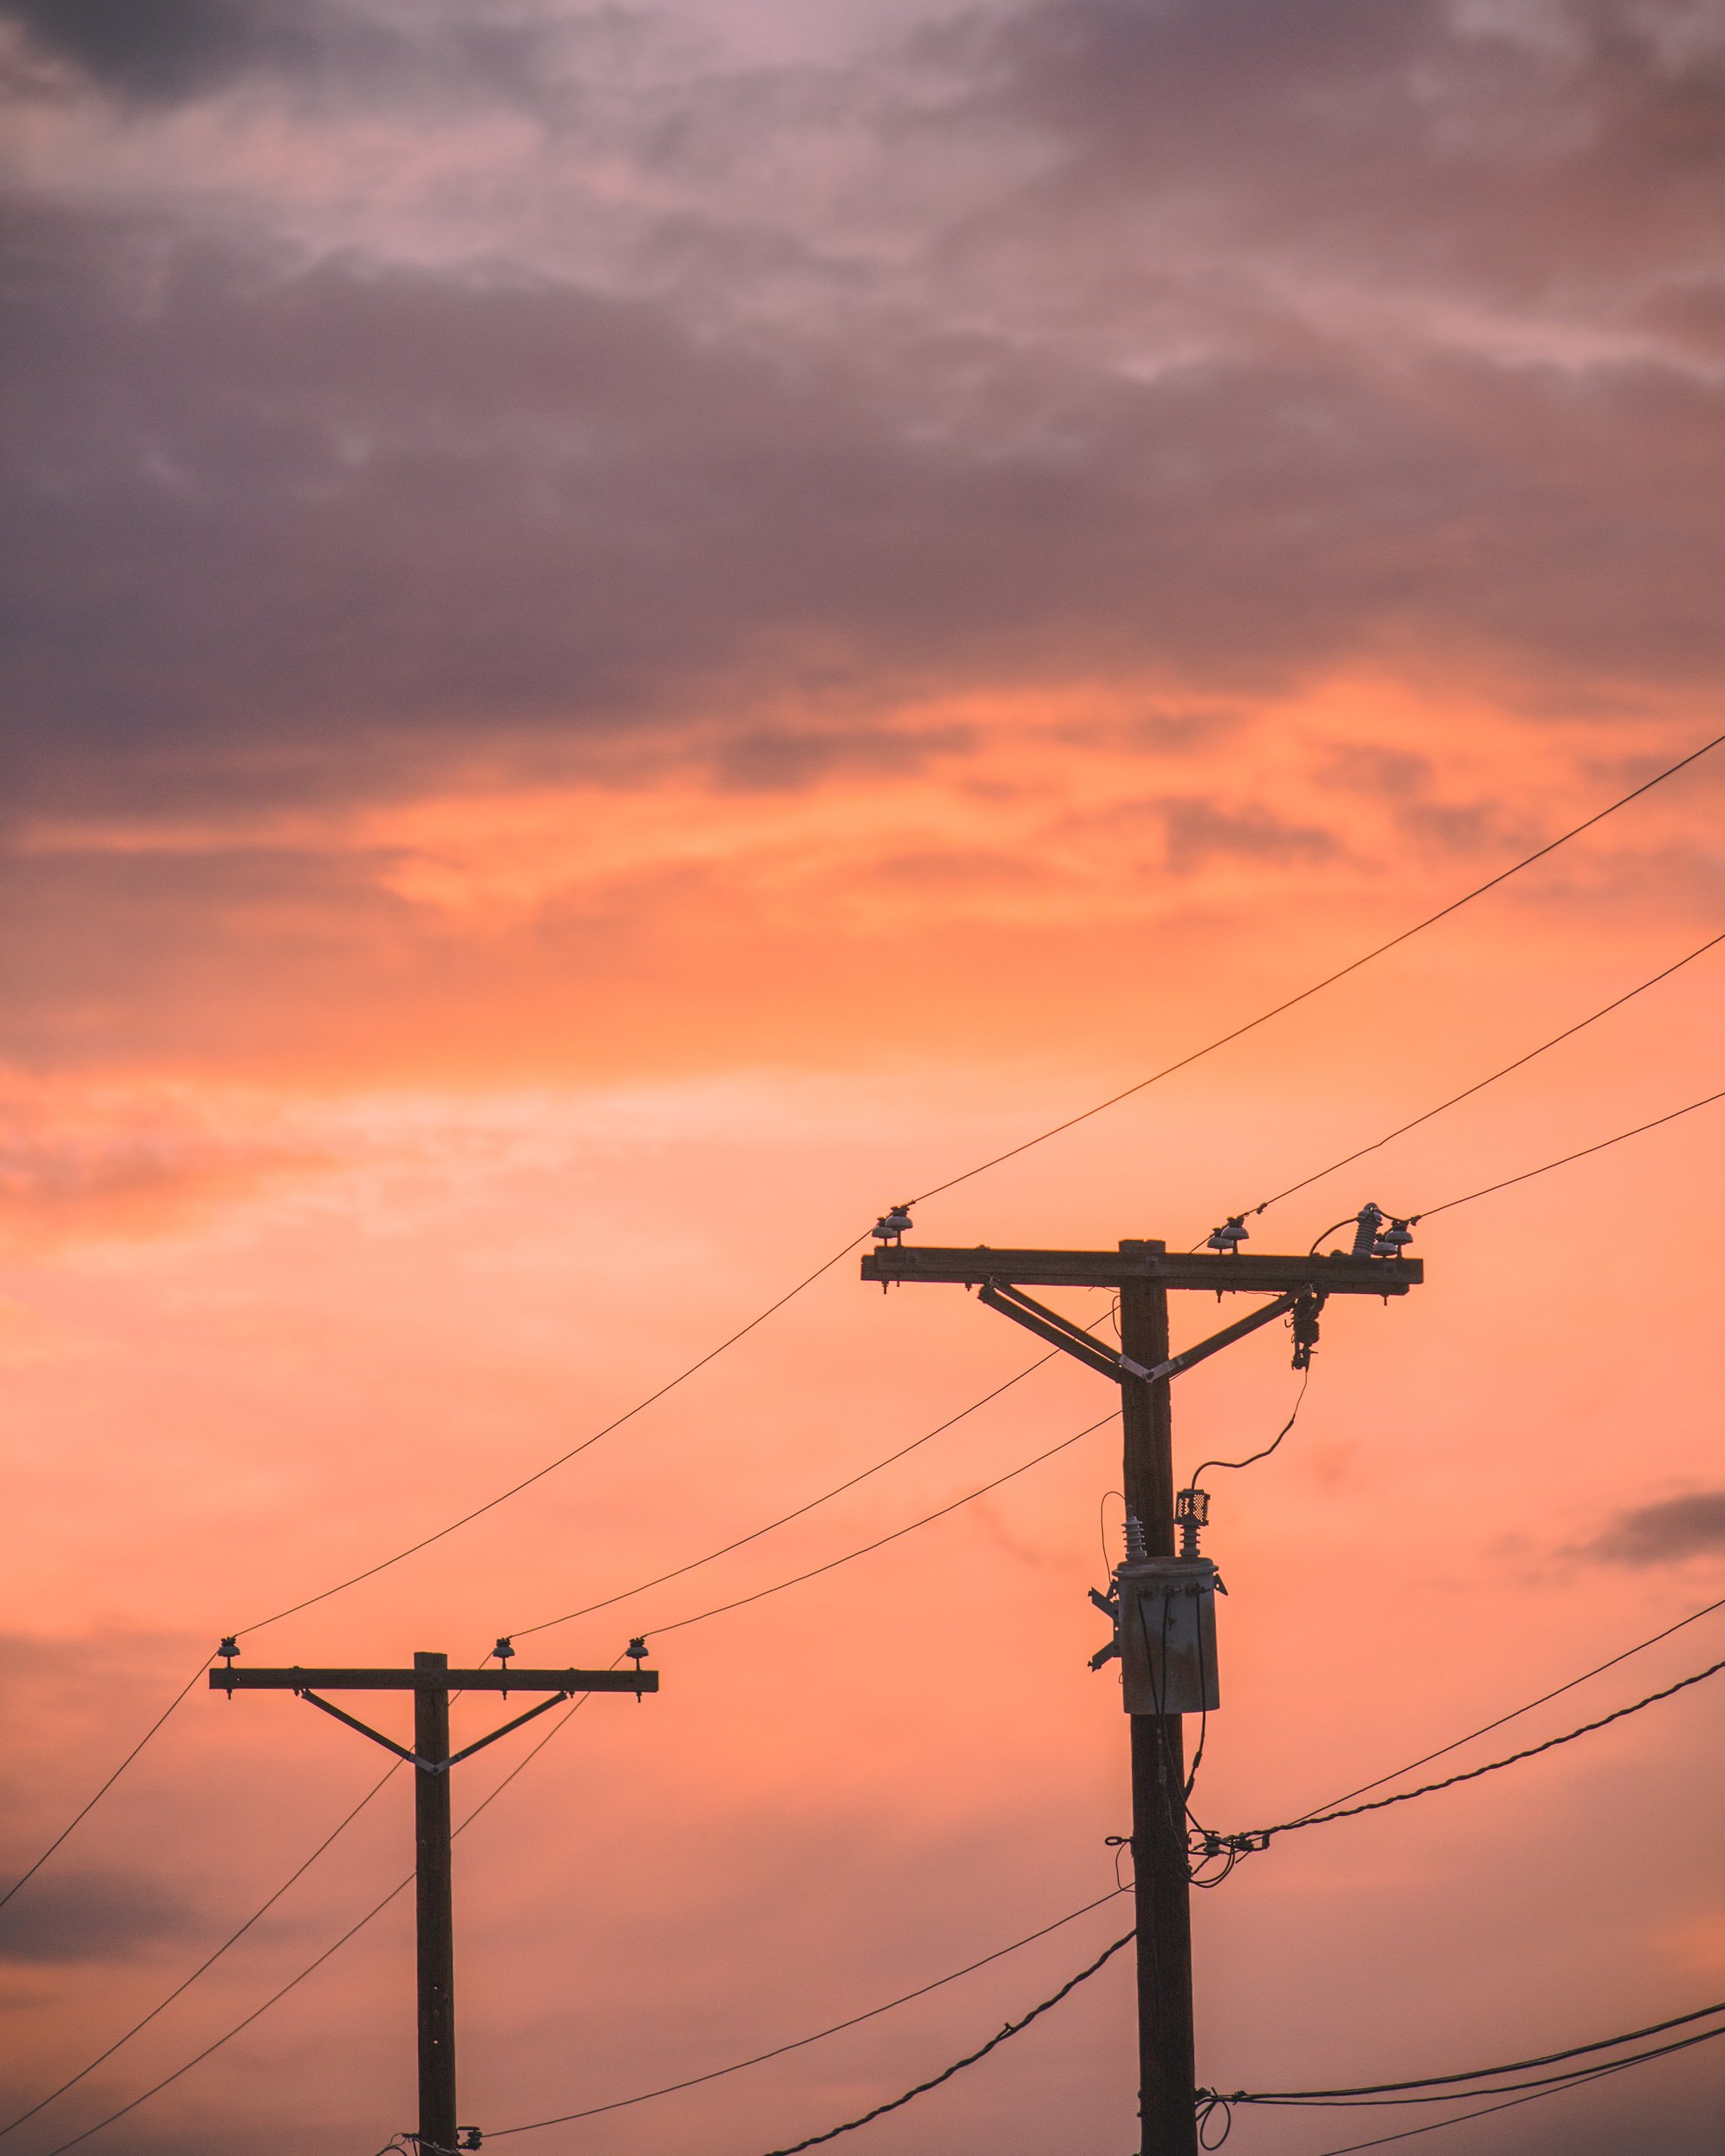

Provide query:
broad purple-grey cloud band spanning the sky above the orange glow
left=4, top=185, right=1725, bottom=827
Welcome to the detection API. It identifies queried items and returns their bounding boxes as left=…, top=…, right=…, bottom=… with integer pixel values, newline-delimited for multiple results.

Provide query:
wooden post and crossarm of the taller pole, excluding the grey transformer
left=863, top=1205, right=1423, bottom=2156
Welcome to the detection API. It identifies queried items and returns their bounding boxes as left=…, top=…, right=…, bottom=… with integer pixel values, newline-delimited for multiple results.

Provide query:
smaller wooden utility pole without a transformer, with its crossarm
left=209, top=1638, right=660, bottom=2156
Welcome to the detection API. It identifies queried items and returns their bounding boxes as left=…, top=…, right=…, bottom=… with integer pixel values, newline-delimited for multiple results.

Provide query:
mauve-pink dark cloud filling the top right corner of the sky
left=970, top=0, right=1725, bottom=306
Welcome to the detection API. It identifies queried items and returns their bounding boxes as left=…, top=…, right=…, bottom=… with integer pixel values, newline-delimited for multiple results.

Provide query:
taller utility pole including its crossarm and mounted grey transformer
left=863, top=1205, right=1425, bottom=2156
